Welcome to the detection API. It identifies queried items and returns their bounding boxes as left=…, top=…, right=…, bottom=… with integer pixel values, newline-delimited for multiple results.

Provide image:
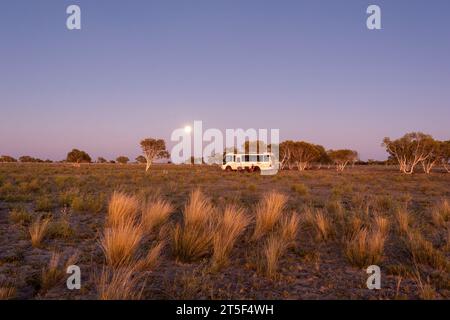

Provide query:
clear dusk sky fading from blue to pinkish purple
left=0, top=0, right=450, bottom=160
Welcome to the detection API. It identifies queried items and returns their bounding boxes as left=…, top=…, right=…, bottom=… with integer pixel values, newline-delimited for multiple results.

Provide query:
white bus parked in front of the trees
left=222, top=152, right=277, bottom=172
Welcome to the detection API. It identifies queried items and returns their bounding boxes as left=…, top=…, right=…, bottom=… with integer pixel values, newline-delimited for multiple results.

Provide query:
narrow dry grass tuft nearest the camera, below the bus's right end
left=259, top=235, right=287, bottom=278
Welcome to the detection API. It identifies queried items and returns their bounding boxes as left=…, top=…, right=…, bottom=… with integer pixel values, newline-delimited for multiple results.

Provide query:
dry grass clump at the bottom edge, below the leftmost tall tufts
left=96, top=265, right=145, bottom=300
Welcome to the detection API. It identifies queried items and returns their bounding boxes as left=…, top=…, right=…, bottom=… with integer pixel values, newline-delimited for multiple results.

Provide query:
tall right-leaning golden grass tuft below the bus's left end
left=212, top=206, right=250, bottom=270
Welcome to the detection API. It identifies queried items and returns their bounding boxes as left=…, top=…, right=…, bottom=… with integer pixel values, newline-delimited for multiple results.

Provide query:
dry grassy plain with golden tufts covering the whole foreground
left=0, top=162, right=450, bottom=299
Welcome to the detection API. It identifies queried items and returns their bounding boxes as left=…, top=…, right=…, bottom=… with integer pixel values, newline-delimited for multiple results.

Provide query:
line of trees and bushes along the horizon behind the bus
left=0, top=132, right=450, bottom=174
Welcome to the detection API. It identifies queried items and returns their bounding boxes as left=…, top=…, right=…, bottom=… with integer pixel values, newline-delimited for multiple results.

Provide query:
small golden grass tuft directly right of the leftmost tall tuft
left=141, top=198, right=174, bottom=233
